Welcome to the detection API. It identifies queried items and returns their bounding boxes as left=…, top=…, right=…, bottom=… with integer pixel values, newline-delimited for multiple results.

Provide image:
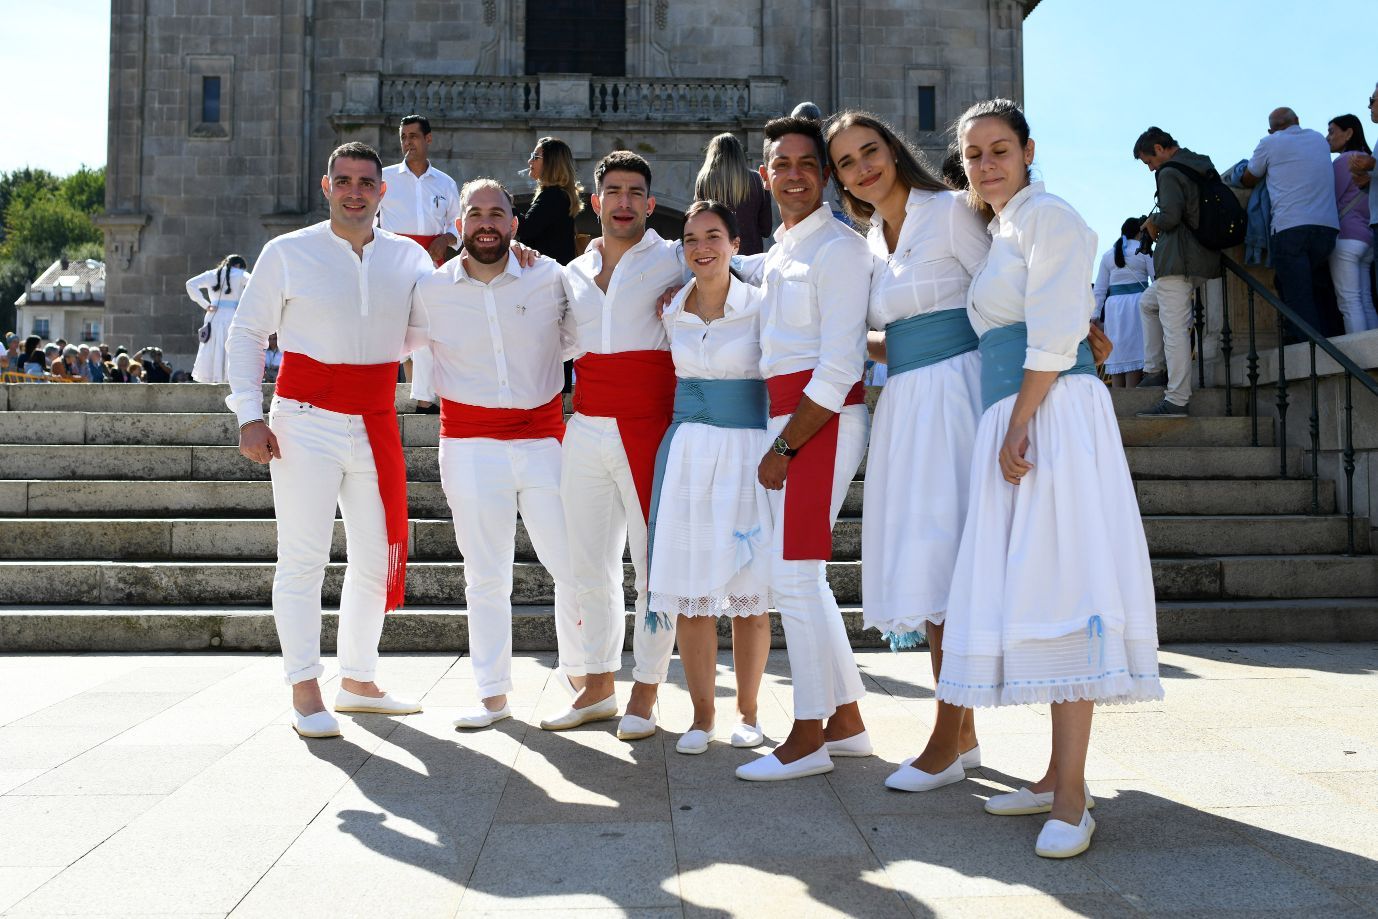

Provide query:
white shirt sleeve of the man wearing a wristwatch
left=803, top=237, right=872, bottom=412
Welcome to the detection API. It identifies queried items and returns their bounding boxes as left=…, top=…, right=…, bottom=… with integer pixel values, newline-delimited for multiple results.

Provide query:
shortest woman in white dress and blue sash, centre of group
left=646, top=201, right=770, bottom=754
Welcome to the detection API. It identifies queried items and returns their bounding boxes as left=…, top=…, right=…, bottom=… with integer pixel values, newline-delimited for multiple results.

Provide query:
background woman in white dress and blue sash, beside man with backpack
left=1094, top=216, right=1153, bottom=389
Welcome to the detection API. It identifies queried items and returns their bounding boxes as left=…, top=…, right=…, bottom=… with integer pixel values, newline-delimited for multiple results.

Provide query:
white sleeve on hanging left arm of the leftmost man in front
left=225, top=240, right=288, bottom=426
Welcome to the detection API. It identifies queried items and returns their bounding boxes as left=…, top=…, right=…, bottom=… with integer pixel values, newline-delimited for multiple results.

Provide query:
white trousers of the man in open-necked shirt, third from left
left=559, top=415, right=675, bottom=683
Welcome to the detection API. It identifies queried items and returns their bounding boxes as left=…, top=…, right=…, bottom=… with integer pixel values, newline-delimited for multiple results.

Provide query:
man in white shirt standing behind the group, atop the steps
left=378, top=114, right=459, bottom=413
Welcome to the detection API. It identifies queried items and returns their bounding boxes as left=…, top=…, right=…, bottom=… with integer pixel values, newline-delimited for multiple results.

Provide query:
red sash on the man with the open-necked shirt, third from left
left=575, top=350, right=675, bottom=521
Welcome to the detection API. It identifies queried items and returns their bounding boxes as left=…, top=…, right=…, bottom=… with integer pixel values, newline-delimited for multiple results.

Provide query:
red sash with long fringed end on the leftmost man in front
left=277, top=351, right=407, bottom=612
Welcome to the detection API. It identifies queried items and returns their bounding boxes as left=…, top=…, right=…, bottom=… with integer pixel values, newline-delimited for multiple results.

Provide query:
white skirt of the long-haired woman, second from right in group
left=861, top=351, right=981, bottom=648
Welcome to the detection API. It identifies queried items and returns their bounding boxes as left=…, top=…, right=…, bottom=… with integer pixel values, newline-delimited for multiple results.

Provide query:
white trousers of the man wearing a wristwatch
left=762, top=405, right=871, bottom=721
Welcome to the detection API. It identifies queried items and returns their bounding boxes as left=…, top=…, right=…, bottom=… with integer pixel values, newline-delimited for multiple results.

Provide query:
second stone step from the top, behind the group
left=0, top=412, right=1273, bottom=446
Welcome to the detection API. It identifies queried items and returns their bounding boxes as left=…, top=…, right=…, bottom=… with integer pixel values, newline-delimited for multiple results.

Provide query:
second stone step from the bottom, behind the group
left=8, top=555, right=1378, bottom=606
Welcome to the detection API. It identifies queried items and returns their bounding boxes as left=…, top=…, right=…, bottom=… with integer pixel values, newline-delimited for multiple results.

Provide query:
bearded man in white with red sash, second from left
left=412, top=179, right=584, bottom=729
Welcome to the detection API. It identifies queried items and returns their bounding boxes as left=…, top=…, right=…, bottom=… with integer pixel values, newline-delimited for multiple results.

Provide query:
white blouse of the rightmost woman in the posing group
left=967, top=182, right=1096, bottom=372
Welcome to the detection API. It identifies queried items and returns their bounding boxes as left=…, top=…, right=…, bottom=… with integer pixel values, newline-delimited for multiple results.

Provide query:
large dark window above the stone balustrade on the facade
left=526, top=0, right=627, bottom=77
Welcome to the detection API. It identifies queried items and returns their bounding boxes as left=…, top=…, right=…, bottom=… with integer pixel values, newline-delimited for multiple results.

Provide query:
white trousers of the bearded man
left=440, top=437, right=584, bottom=699
